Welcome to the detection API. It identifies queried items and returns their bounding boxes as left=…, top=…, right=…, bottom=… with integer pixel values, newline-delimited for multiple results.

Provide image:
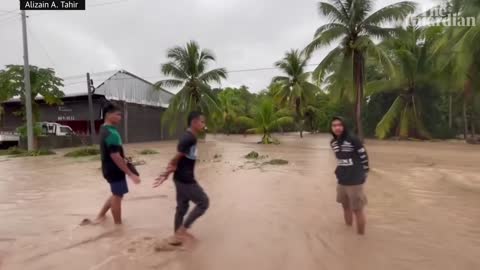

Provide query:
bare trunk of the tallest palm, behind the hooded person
left=353, top=50, right=364, bottom=141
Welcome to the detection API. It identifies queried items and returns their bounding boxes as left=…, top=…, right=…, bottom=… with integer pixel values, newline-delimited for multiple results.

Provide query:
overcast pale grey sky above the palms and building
left=0, top=0, right=433, bottom=92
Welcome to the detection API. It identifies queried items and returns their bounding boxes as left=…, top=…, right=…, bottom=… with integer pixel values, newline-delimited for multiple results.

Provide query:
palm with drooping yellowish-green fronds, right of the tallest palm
left=367, top=26, right=442, bottom=139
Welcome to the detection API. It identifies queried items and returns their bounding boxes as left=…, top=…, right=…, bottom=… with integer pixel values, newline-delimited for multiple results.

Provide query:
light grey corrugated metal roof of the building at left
left=95, top=70, right=174, bottom=108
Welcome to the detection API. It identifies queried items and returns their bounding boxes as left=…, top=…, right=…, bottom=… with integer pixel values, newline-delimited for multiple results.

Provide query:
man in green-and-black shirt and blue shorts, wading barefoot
left=95, top=104, right=140, bottom=224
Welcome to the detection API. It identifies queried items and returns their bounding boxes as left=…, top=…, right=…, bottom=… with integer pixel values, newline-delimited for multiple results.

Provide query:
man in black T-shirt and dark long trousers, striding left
left=154, top=112, right=209, bottom=244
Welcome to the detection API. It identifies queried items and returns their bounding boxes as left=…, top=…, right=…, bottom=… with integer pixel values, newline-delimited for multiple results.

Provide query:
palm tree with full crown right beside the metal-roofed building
left=156, top=41, right=227, bottom=131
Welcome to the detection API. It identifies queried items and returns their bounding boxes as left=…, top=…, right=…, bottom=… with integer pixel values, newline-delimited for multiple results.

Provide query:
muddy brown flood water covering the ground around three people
left=0, top=135, right=480, bottom=270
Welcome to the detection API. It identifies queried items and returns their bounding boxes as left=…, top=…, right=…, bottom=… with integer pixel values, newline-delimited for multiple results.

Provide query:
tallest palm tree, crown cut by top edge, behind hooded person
left=306, top=0, right=416, bottom=139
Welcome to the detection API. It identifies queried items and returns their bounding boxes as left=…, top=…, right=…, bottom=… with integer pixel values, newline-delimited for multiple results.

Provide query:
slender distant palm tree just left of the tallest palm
left=272, top=50, right=320, bottom=138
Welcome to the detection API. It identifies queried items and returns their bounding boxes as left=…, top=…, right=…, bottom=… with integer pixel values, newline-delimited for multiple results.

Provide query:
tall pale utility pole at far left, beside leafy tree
left=22, top=10, right=35, bottom=151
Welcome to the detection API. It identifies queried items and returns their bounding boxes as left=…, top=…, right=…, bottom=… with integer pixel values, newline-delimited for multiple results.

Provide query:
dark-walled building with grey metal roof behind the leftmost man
left=0, top=70, right=181, bottom=146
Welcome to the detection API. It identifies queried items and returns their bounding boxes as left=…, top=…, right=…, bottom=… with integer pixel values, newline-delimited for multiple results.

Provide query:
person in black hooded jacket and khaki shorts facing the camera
left=330, top=117, right=369, bottom=234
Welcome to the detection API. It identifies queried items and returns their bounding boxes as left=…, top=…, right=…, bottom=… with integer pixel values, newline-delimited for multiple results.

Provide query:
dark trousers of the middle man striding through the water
left=174, top=181, right=210, bottom=231
